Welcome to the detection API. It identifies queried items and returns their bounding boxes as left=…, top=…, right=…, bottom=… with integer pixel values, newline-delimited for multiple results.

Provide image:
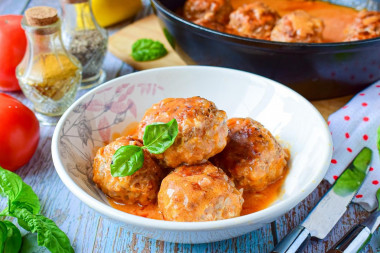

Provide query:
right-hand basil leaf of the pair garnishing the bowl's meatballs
left=143, top=119, right=178, bottom=154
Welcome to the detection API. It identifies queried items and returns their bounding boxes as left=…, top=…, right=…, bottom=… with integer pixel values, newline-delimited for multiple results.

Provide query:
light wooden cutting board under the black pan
left=108, top=15, right=352, bottom=120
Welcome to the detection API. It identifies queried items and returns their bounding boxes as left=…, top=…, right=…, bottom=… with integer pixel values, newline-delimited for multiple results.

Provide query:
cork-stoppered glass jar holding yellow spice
left=16, top=6, right=82, bottom=125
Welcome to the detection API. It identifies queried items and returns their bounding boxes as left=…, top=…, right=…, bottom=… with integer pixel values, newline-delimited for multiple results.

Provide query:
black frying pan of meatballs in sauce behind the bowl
left=151, top=0, right=380, bottom=99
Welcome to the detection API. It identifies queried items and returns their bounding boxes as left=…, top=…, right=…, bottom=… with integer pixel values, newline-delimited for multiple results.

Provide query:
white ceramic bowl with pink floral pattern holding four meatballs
left=52, top=66, right=332, bottom=243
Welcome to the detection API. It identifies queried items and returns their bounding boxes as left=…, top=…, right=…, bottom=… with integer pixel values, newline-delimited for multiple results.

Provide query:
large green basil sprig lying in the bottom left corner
left=0, top=167, right=74, bottom=253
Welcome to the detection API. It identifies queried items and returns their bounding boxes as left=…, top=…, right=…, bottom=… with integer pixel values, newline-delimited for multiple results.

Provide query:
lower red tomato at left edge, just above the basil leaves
left=0, top=93, right=40, bottom=171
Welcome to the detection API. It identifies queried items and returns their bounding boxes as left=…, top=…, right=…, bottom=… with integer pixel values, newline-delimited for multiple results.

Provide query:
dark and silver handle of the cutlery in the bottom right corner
left=327, top=224, right=372, bottom=253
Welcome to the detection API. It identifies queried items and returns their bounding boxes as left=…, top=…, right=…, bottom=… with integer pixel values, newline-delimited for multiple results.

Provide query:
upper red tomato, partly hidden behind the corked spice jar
left=0, top=15, right=26, bottom=91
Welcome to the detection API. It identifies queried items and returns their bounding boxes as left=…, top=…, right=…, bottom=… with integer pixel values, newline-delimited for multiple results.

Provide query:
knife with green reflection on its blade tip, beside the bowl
left=272, top=147, right=372, bottom=253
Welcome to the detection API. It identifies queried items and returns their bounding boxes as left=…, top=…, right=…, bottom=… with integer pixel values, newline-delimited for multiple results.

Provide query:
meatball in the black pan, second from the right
left=271, top=10, right=324, bottom=43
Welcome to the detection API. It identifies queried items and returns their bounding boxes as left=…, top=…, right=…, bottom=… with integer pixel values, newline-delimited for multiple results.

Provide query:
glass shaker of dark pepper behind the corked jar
left=62, top=0, right=108, bottom=89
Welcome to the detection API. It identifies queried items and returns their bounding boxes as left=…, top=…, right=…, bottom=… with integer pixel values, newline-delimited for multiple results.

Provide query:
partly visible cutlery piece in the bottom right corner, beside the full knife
left=328, top=189, right=380, bottom=253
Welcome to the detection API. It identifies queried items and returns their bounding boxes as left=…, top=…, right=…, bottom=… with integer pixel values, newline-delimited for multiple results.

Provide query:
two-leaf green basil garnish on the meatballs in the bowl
left=111, top=119, right=178, bottom=177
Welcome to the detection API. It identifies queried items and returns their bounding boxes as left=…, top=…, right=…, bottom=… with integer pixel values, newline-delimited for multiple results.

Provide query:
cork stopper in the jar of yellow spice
left=25, top=6, right=58, bottom=26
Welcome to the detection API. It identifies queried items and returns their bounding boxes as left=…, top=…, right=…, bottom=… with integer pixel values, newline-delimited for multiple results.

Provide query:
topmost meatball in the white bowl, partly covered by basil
left=139, top=97, right=228, bottom=168
